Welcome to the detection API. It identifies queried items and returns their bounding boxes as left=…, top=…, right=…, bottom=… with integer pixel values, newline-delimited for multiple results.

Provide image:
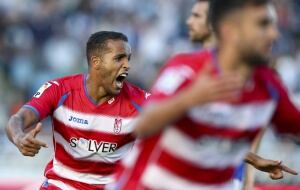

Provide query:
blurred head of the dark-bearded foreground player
left=209, top=0, right=278, bottom=65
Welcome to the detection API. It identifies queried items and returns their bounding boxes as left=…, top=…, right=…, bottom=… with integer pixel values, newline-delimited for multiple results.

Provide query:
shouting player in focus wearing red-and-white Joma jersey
left=7, top=31, right=148, bottom=190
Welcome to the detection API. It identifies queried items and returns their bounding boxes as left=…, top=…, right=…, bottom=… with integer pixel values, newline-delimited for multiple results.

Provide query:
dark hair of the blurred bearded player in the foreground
left=209, top=0, right=270, bottom=34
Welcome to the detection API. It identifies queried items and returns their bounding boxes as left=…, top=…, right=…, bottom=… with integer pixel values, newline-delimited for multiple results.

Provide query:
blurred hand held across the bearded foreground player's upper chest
left=188, top=63, right=243, bottom=105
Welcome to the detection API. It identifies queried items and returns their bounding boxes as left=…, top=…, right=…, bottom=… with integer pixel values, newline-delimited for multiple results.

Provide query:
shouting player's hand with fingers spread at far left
left=15, top=123, right=47, bottom=157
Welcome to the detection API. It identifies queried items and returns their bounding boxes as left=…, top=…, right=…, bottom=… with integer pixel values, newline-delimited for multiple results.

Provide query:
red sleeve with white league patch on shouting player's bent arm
left=23, top=81, right=60, bottom=120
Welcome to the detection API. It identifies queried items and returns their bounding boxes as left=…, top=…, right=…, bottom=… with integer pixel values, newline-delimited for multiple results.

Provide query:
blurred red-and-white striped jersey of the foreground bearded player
left=115, top=51, right=300, bottom=190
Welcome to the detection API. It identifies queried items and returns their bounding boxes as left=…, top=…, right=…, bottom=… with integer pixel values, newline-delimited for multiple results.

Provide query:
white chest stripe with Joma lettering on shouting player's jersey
left=53, top=105, right=136, bottom=134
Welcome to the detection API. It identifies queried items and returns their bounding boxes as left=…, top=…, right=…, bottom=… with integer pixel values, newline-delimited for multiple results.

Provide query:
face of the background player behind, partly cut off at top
left=186, top=2, right=210, bottom=43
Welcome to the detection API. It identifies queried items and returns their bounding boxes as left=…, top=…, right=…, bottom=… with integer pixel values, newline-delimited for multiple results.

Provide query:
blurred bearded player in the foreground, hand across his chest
left=116, top=0, right=300, bottom=190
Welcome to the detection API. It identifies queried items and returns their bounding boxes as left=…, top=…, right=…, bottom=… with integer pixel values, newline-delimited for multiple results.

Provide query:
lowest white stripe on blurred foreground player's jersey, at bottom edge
left=141, top=165, right=233, bottom=190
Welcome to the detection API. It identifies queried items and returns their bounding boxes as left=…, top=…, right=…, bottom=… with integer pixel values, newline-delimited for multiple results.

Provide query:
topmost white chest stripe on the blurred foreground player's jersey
left=188, top=100, right=276, bottom=130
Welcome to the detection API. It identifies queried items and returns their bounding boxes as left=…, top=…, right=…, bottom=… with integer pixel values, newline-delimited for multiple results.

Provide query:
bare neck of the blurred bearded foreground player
left=218, top=47, right=252, bottom=80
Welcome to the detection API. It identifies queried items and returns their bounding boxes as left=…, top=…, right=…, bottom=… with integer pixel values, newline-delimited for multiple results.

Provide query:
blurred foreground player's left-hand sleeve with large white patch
left=147, top=57, right=195, bottom=103
